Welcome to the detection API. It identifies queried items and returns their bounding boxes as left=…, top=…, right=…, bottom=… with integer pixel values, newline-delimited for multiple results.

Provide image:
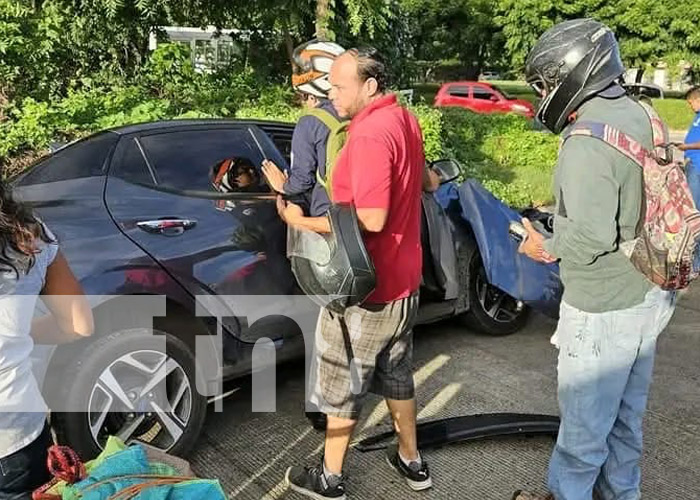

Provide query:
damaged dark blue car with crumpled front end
left=13, top=120, right=561, bottom=458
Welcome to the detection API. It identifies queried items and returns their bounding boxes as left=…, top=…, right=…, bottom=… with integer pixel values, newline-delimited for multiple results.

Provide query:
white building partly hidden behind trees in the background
left=148, top=26, right=247, bottom=72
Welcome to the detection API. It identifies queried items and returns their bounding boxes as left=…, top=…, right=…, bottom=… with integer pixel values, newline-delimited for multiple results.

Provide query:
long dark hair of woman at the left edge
left=0, top=180, right=54, bottom=278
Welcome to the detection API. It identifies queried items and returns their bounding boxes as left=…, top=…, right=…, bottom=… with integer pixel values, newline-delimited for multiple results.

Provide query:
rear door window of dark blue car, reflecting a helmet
left=140, top=129, right=269, bottom=193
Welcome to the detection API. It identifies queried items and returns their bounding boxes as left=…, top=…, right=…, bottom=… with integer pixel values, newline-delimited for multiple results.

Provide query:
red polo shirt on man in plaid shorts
left=332, top=95, right=425, bottom=303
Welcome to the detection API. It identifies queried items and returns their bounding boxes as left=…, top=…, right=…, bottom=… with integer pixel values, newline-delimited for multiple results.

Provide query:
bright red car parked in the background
left=435, top=81, right=535, bottom=118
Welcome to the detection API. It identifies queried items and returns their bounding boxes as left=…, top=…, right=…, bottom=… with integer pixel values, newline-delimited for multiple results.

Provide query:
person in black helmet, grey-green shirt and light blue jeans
left=513, top=19, right=675, bottom=500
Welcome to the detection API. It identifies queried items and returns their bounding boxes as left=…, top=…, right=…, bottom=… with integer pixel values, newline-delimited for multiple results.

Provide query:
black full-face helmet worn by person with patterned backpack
left=525, top=19, right=625, bottom=134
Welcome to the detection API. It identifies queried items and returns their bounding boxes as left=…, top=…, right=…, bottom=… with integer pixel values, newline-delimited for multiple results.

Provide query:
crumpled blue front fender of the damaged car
left=436, top=179, right=562, bottom=315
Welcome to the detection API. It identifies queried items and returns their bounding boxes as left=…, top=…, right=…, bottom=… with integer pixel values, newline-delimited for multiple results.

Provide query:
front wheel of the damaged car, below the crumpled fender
left=461, top=252, right=529, bottom=336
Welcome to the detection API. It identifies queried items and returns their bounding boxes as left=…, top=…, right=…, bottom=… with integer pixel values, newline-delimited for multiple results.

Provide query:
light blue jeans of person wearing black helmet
left=548, top=287, right=675, bottom=500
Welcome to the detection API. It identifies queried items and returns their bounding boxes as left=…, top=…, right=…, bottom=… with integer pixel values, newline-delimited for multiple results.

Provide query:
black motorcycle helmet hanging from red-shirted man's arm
left=287, top=204, right=376, bottom=314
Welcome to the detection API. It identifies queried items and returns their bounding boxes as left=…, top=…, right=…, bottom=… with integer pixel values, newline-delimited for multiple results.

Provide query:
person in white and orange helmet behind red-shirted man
left=263, top=40, right=345, bottom=216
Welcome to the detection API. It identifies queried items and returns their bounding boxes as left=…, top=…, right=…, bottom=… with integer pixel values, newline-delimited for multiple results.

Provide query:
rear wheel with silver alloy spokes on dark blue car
left=51, top=329, right=207, bottom=460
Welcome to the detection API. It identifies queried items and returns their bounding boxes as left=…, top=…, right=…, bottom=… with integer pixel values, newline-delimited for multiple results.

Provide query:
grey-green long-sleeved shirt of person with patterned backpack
left=544, top=96, right=652, bottom=313
